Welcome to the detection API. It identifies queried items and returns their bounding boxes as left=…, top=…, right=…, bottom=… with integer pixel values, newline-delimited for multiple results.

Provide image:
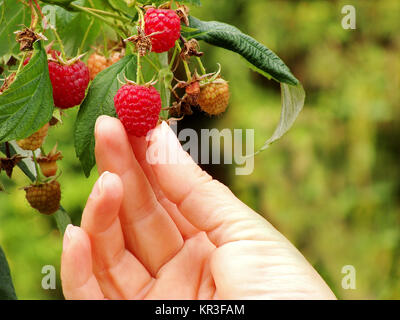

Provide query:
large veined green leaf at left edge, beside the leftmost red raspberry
left=0, top=41, right=54, bottom=142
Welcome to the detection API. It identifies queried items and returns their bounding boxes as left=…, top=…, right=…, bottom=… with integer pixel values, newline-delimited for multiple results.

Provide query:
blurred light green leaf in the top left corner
left=0, top=0, right=30, bottom=57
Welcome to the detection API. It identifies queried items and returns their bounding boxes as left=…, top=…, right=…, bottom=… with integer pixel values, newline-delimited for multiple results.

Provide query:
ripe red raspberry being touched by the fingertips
left=114, top=84, right=161, bottom=137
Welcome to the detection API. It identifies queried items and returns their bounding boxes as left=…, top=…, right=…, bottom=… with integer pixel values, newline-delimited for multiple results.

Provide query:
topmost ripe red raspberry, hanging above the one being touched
left=144, top=8, right=181, bottom=53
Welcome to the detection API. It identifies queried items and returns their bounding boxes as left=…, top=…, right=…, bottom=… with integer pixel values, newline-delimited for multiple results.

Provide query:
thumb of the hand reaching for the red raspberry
left=146, top=122, right=287, bottom=246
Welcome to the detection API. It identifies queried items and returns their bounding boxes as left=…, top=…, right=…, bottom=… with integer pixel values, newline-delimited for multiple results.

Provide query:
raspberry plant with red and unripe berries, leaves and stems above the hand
left=0, top=0, right=305, bottom=297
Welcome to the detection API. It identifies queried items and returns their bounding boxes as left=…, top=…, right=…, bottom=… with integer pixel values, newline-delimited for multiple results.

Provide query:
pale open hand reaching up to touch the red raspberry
left=61, top=116, right=335, bottom=299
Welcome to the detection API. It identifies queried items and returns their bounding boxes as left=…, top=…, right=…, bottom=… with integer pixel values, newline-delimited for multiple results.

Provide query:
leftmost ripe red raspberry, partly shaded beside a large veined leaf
left=49, top=60, right=90, bottom=109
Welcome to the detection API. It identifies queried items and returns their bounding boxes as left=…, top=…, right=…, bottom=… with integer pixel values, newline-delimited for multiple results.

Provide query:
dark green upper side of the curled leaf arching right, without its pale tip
left=186, top=16, right=299, bottom=85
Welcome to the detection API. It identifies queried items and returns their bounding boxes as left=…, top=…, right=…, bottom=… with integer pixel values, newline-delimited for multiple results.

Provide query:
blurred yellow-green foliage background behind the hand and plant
left=0, top=0, right=400, bottom=299
